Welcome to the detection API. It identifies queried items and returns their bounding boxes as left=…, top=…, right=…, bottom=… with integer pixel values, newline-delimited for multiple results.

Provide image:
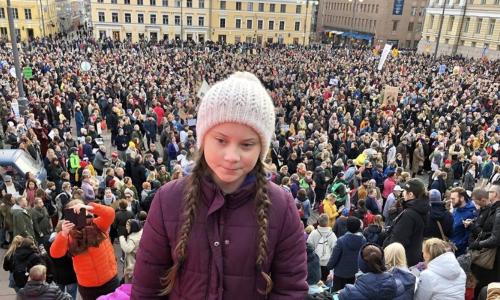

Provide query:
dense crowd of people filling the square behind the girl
left=0, top=27, right=500, bottom=299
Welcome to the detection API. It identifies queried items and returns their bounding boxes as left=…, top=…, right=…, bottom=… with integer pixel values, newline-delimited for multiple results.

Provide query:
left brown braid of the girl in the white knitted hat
left=160, top=154, right=207, bottom=296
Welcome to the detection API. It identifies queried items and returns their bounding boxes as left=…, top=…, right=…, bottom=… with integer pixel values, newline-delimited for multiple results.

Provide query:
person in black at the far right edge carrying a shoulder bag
left=469, top=184, right=500, bottom=295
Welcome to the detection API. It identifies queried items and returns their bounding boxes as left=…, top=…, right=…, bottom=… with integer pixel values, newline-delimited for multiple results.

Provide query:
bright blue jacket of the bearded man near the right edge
left=451, top=201, right=476, bottom=257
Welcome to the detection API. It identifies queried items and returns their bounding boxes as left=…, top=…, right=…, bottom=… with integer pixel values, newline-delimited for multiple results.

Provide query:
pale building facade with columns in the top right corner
left=418, top=0, right=500, bottom=59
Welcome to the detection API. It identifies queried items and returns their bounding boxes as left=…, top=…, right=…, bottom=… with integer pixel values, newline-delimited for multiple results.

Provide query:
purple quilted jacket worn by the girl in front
left=131, top=178, right=308, bottom=300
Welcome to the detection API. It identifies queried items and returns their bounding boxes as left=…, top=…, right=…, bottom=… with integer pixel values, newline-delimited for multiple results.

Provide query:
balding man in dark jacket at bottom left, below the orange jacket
left=16, top=265, right=73, bottom=300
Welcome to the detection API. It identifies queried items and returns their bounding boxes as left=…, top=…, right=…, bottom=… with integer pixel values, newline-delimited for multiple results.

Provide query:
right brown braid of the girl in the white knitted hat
left=255, top=161, right=273, bottom=295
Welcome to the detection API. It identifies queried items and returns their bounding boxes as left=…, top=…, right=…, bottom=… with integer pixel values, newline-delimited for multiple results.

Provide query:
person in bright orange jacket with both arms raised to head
left=50, top=200, right=119, bottom=300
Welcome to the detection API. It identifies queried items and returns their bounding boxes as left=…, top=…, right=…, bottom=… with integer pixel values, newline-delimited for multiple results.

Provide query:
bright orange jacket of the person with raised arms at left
left=50, top=203, right=118, bottom=287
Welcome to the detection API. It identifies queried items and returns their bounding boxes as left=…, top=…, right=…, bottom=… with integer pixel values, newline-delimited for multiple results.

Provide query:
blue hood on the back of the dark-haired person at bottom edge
left=350, top=272, right=397, bottom=300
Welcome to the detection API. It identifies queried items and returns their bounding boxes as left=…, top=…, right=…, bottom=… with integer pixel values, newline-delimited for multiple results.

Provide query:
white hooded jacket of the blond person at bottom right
left=414, top=252, right=465, bottom=300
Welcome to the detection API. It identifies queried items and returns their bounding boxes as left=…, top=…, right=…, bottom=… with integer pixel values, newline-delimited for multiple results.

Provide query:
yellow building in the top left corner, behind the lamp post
left=0, top=0, right=59, bottom=41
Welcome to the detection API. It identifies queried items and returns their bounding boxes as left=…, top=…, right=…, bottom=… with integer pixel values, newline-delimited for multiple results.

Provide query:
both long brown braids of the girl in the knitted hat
left=160, top=153, right=273, bottom=296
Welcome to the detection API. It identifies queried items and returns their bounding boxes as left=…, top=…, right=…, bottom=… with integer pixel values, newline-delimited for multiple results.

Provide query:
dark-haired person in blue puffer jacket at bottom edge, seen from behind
left=339, top=243, right=406, bottom=300
